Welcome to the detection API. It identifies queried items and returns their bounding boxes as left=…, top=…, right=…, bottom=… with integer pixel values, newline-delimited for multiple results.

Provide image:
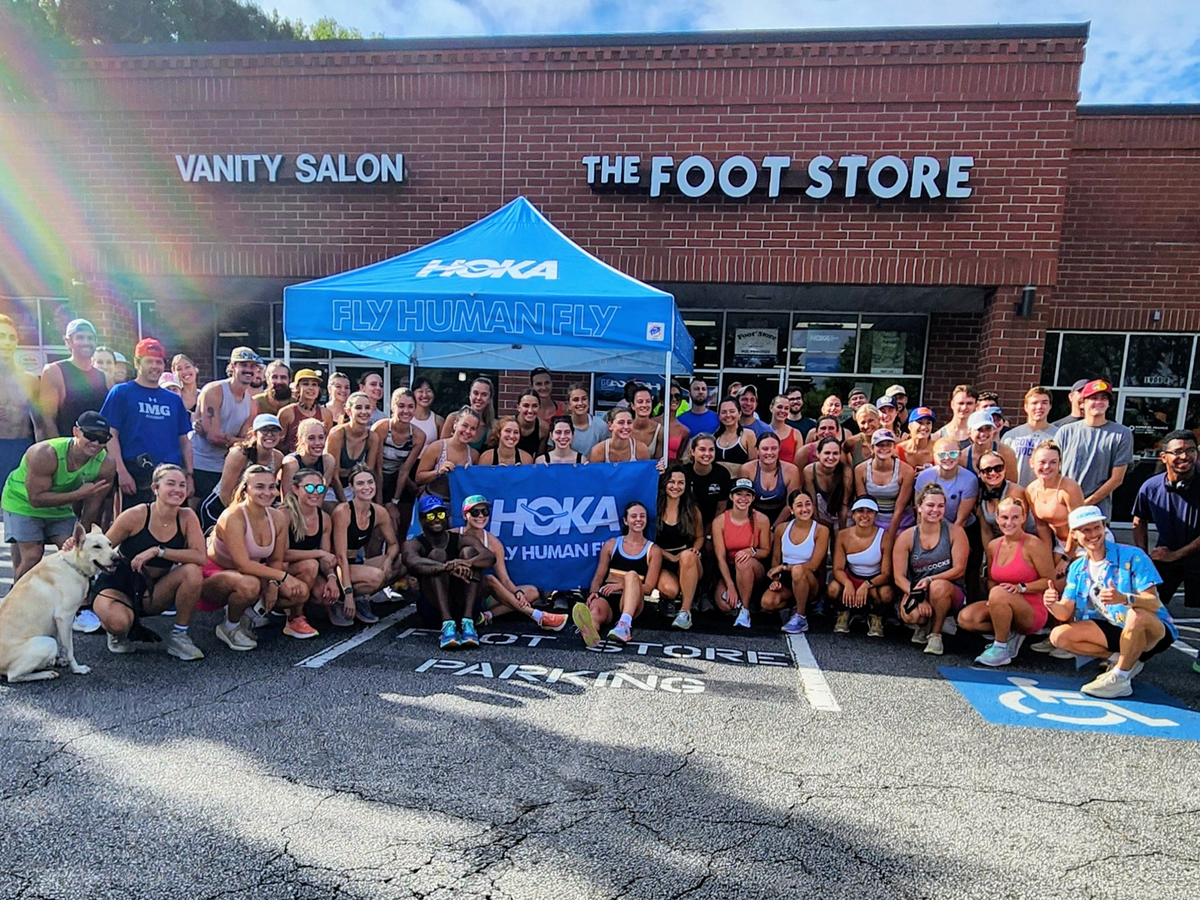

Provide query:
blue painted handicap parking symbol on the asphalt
left=937, top=666, right=1200, bottom=740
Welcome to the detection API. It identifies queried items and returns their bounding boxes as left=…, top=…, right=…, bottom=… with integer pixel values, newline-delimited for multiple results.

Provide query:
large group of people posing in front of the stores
left=0, top=317, right=1200, bottom=696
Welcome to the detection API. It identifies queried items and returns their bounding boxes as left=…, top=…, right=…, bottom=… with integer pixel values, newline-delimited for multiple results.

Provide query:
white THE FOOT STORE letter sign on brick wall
left=581, top=152, right=974, bottom=200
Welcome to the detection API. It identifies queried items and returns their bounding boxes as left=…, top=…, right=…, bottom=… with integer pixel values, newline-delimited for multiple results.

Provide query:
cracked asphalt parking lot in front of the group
left=0, top=549, right=1200, bottom=900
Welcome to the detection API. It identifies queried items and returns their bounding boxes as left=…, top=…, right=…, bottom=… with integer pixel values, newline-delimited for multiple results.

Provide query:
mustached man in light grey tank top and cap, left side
left=192, top=347, right=263, bottom=499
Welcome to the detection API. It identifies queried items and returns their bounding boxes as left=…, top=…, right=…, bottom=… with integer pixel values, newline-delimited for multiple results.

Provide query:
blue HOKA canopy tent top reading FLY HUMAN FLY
left=283, top=197, right=694, bottom=376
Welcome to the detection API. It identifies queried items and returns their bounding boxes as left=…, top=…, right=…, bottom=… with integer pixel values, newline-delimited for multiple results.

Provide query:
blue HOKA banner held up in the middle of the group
left=450, top=461, right=659, bottom=590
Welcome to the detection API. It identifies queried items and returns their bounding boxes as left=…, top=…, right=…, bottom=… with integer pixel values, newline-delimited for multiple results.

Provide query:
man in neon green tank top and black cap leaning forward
left=0, top=410, right=116, bottom=582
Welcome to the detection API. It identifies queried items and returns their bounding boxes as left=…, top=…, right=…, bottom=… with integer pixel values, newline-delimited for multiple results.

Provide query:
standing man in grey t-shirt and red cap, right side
left=1055, top=378, right=1133, bottom=516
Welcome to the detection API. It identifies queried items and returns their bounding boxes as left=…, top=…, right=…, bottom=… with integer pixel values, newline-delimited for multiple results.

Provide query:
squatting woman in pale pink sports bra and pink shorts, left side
left=199, top=466, right=308, bottom=650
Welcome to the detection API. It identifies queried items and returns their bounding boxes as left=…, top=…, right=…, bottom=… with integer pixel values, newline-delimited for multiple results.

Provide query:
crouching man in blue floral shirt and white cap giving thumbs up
left=1043, top=505, right=1178, bottom=697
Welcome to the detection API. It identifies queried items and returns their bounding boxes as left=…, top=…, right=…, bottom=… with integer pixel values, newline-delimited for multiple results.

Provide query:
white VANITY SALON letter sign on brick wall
left=175, top=154, right=404, bottom=185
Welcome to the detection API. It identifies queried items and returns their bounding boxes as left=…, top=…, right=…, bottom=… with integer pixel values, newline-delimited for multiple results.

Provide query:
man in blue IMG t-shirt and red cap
left=100, top=337, right=192, bottom=508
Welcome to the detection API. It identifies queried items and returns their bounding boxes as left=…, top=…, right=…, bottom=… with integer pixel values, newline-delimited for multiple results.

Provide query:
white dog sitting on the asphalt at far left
left=0, top=524, right=120, bottom=683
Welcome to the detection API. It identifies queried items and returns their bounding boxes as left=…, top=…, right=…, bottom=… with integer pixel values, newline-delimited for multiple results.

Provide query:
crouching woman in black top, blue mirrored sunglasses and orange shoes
left=283, top=469, right=342, bottom=638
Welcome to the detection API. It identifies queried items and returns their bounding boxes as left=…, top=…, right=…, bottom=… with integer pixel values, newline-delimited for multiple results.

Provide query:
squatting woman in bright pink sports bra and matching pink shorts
left=959, top=497, right=1054, bottom=666
